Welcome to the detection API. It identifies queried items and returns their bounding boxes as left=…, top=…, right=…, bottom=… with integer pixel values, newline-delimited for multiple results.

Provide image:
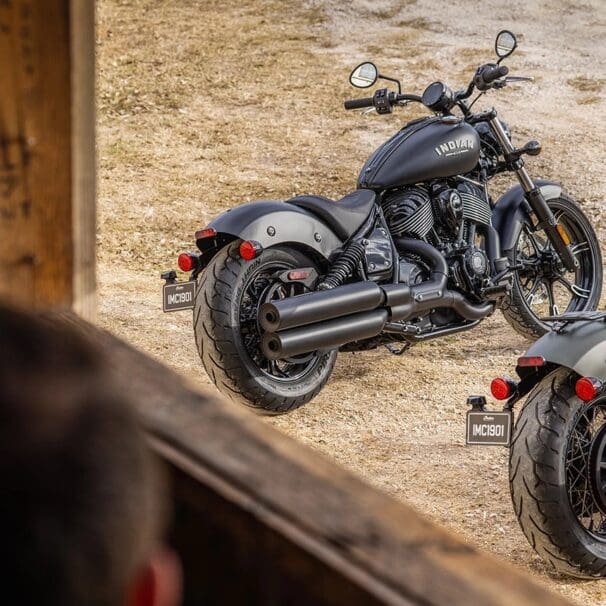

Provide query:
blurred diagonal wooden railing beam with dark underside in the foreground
left=54, top=318, right=569, bottom=606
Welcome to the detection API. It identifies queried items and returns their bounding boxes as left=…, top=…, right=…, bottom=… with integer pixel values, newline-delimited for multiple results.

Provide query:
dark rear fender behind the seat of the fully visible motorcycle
left=208, top=200, right=343, bottom=259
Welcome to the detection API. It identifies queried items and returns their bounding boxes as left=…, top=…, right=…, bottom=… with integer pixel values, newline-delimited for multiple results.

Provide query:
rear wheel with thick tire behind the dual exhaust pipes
left=194, top=241, right=337, bottom=414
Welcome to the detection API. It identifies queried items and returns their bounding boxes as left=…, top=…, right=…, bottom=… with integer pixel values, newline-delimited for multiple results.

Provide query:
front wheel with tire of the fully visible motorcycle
left=503, top=197, right=602, bottom=339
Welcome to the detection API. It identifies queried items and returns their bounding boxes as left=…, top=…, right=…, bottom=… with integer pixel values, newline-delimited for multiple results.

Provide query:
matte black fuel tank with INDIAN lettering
left=358, top=116, right=480, bottom=190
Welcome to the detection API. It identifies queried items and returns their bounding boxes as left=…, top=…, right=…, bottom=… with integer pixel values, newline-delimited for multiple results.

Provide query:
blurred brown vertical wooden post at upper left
left=0, top=0, right=95, bottom=318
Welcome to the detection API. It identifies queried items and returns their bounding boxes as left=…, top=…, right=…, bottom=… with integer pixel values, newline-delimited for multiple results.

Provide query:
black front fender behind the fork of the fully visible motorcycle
left=492, top=179, right=562, bottom=253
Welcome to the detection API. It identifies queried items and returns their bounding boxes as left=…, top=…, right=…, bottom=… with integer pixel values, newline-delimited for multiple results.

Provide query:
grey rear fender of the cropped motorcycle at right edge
left=517, top=320, right=606, bottom=380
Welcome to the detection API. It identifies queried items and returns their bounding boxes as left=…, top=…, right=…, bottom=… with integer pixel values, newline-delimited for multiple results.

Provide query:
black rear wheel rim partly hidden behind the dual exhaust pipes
left=239, top=261, right=321, bottom=383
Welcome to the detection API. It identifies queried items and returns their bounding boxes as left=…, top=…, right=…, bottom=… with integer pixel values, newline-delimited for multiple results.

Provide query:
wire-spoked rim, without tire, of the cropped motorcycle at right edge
left=565, top=399, right=606, bottom=542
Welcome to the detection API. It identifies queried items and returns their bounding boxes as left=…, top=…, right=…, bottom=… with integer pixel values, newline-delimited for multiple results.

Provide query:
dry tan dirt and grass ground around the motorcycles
left=97, top=0, right=606, bottom=604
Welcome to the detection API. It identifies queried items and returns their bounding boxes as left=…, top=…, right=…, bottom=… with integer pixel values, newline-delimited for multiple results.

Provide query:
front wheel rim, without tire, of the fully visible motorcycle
left=515, top=201, right=599, bottom=318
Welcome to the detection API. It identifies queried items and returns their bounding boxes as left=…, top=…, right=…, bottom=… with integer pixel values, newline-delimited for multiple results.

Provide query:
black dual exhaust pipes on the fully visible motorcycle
left=259, top=238, right=494, bottom=360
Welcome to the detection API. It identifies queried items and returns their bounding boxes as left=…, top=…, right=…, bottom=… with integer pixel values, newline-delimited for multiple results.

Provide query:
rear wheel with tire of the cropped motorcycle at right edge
left=509, top=368, right=606, bottom=578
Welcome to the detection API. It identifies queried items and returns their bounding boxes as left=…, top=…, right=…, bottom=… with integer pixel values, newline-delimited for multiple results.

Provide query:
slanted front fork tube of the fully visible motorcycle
left=489, top=115, right=579, bottom=271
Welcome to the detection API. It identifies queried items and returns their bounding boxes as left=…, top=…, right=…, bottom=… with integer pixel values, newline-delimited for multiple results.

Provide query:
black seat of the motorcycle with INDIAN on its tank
left=286, top=189, right=376, bottom=240
